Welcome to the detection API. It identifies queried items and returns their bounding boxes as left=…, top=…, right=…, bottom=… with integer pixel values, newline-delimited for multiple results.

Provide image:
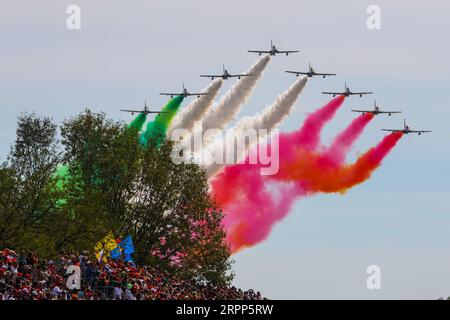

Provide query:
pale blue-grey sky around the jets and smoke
left=0, top=0, right=450, bottom=299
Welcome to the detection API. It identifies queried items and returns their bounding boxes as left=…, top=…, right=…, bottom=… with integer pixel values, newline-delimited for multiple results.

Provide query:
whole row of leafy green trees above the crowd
left=0, top=110, right=232, bottom=283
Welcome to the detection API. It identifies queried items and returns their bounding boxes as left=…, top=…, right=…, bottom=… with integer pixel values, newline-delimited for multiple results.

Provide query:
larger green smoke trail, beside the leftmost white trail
left=140, top=96, right=184, bottom=146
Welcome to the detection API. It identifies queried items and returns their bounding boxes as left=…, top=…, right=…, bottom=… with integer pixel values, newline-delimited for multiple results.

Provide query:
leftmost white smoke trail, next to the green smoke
left=167, top=79, right=223, bottom=139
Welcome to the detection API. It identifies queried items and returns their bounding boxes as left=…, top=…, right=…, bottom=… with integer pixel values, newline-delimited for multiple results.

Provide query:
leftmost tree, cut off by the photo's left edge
left=0, top=114, right=61, bottom=253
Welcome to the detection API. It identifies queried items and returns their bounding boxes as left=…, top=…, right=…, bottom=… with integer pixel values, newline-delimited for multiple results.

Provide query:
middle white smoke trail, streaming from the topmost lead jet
left=184, top=55, right=270, bottom=153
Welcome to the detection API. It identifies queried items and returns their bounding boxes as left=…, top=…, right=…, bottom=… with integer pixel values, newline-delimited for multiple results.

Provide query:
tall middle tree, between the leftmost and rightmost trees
left=54, top=110, right=132, bottom=255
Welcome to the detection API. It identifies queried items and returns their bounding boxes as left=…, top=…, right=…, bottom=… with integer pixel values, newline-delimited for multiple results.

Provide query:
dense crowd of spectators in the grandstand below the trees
left=0, top=249, right=264, bottom=300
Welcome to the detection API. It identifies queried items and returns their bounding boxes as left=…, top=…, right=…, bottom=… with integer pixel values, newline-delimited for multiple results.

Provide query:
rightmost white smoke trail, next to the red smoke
left=204, top=77, right=308, bottom=178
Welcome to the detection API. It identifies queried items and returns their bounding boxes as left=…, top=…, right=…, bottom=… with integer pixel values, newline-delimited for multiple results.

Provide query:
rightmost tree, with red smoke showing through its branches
left=121, top=141, right=231, bottom=283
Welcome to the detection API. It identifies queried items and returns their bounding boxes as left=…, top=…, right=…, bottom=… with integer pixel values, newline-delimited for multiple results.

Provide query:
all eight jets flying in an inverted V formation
left=121, top=41, right=431, bottom=135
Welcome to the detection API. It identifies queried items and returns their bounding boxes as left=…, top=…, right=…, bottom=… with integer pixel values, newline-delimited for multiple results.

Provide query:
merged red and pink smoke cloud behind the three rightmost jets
left=211, top=97, right=402, bottom=253
